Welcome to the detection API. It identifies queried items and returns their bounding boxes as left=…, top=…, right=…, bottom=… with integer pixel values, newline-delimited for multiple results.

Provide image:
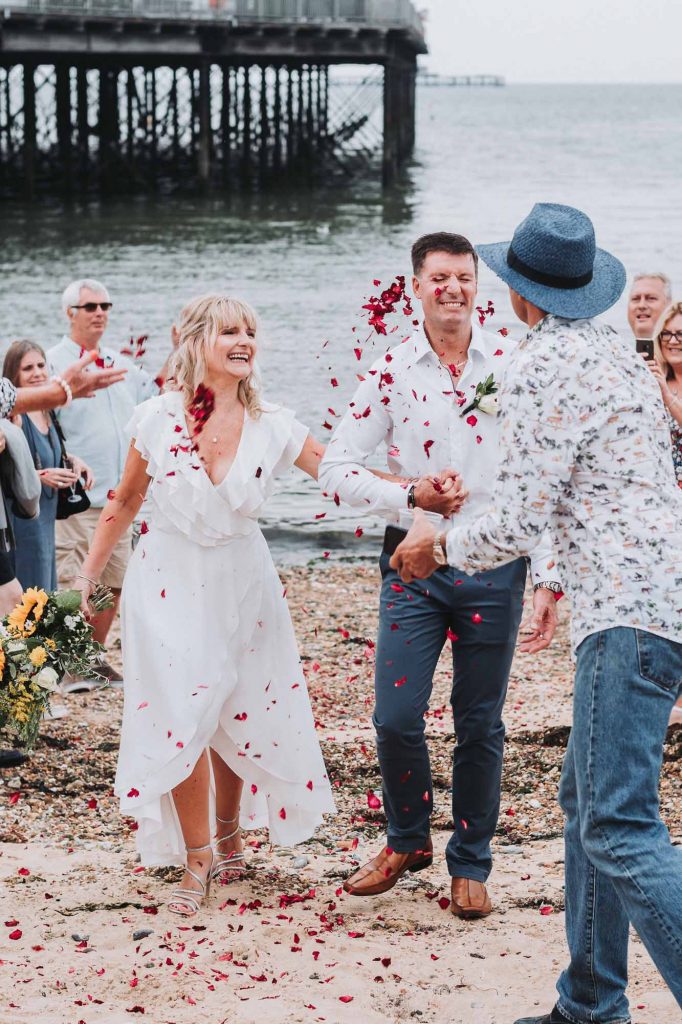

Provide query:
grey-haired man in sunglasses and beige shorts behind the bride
left=47, top=279, right=174, bottom=692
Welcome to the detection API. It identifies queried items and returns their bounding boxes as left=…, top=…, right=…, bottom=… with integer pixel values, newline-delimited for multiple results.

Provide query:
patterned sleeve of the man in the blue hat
left=446, top=374, right=581, bottom=584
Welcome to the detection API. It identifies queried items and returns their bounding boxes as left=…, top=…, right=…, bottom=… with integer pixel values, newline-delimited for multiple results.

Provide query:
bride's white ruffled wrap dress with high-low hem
left=116, top=392, right=335, bottom=865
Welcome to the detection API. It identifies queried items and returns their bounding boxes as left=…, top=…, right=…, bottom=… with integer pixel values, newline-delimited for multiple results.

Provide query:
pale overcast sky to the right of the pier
left=415, top=0, right=682, bottom=82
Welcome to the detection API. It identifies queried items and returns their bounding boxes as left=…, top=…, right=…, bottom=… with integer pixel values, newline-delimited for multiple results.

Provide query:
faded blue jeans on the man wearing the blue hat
left=557, top=627, right=682, bottom=1024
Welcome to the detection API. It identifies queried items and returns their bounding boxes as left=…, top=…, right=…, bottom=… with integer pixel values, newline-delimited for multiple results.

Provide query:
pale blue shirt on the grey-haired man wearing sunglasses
left=47, top=335, right=159, bottom=509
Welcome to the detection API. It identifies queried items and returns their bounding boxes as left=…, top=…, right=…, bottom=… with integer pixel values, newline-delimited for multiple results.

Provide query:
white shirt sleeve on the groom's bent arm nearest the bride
left=318, top=377, right=408, bottom=515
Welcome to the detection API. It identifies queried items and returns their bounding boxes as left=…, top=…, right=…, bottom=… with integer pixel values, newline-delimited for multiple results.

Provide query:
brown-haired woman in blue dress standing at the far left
left=2, top=340, right=93, bottom=591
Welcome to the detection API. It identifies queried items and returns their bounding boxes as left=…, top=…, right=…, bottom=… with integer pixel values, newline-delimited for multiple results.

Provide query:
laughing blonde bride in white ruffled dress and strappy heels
left=79, top=295, right=335, bottom=916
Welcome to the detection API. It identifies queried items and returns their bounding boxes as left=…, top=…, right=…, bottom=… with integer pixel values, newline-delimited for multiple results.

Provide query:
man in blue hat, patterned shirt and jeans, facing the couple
left=392, top=203, right=682, bottom=1024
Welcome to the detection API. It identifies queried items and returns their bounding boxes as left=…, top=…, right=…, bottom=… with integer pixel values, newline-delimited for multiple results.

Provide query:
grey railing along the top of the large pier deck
left=3, top=0, right=424, bottom=37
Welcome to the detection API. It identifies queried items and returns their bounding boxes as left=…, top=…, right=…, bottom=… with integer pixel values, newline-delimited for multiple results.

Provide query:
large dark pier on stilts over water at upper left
left=0, top=0, right=426, bottom=199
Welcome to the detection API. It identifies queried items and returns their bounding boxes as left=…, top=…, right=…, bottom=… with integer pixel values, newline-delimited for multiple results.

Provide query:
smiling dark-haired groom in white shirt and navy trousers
left=319, top=232, right=561, bottom=919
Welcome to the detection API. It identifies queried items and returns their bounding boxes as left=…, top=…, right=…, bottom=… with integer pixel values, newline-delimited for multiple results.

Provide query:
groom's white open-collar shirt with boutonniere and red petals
left=319, top=324, right=559, bottom=584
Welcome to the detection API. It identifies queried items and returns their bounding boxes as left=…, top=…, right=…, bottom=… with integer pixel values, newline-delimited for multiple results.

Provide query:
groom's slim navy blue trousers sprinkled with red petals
left=374, top=554, right=526, bottom=882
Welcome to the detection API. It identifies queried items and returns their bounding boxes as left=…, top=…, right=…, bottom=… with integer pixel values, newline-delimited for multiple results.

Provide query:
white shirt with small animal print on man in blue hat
left=447, top=315, right=682, bottom=649
